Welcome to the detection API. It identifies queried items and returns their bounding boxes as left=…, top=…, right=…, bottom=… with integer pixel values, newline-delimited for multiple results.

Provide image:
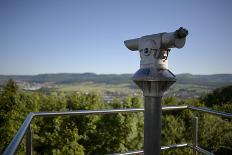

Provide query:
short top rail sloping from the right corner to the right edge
left=188, top=106, right=232, bottom=118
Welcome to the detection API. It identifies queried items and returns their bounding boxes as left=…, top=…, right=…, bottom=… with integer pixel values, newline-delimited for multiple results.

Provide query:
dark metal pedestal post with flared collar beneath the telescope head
left=133, top=68, right=176, bottom=155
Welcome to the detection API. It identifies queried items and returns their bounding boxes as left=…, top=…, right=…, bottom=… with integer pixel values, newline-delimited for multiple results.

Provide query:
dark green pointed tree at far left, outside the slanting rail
left=0, top=79, right=37, bottom=152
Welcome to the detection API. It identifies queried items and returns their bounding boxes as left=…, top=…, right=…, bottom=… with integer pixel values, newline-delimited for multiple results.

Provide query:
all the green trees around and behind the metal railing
left=0, top=80, right=232, bottom=155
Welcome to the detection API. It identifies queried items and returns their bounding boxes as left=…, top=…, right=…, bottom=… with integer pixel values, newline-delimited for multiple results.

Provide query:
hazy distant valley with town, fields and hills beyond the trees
left=0, top=73, right=232, bottom=102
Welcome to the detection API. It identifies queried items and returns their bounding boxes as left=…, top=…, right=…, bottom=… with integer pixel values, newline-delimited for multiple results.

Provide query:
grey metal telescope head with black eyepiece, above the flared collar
left=124, top=27, right=188, bottom=69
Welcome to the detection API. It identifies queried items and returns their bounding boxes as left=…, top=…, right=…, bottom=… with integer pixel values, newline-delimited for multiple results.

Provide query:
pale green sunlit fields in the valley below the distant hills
left=54, top=82, right=214, bottom=98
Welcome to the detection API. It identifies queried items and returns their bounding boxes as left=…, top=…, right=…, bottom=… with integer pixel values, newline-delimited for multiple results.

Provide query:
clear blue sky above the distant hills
left=0, top=0, right=232, bottom=75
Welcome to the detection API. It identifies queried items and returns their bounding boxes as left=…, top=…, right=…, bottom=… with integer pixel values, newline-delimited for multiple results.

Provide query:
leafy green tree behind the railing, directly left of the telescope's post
left=89, top=96, right=143, bottom=154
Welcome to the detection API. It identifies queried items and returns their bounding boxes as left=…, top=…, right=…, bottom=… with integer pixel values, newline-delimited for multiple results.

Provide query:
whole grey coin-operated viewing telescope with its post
left=124, top=27, right=188, bottom=155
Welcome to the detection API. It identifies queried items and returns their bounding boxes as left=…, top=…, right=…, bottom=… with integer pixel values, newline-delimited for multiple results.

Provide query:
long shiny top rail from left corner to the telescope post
left=34, top=108, right=144, bottom=117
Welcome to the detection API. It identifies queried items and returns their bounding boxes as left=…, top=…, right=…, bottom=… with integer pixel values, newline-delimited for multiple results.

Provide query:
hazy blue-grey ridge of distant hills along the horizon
left=0, top=73, right=232, bottom=87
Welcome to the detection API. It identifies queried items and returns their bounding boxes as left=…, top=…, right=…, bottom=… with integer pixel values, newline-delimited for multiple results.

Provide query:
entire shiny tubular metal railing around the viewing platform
left=3, top=105, right=232, bottom=155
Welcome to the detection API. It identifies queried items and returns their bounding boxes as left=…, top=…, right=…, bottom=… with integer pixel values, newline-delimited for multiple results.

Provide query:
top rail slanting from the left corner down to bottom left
left=3, top=112, right=34, bottom=155
